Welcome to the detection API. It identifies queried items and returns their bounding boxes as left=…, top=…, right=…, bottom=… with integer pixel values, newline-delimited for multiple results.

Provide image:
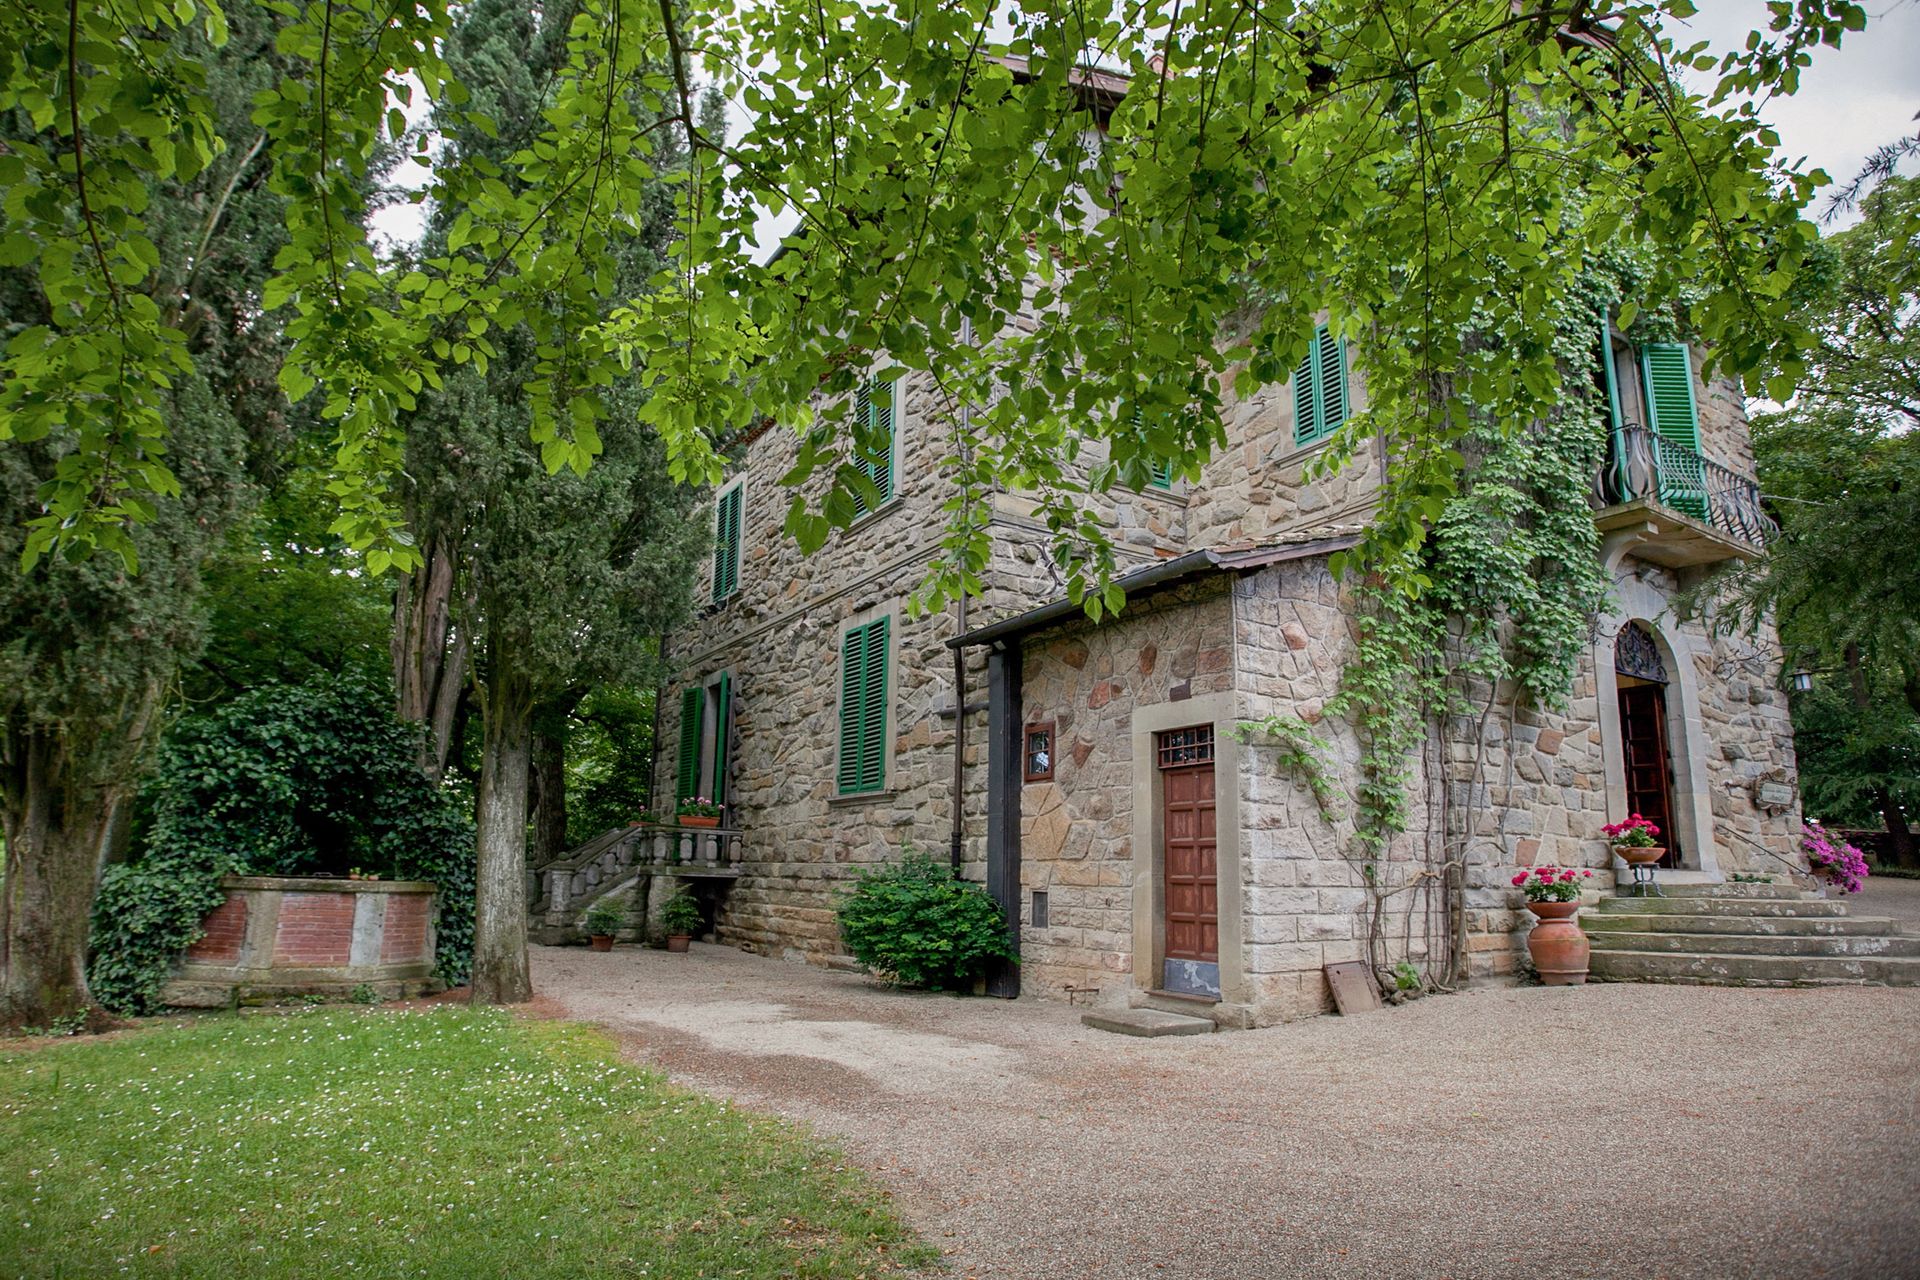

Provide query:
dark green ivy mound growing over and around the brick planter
left=88, top=679, right=474, bottom=1011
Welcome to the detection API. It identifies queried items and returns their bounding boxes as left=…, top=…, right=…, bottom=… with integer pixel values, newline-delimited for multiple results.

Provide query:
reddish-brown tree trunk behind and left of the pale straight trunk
left=392, top=537, right=468, bottom=783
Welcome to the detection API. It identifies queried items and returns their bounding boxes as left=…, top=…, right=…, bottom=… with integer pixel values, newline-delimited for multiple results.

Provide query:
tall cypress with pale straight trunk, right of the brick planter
left=396, top=0, right=701, bottom=1002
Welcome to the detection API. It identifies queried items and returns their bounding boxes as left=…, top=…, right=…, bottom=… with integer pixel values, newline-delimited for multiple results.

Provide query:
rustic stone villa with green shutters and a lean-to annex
left=543, top=72, right=1835, bottom=1027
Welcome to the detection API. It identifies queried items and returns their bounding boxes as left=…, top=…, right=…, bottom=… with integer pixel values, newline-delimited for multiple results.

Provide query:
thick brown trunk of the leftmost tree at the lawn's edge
left=0, top=729, right=117, bottom=1029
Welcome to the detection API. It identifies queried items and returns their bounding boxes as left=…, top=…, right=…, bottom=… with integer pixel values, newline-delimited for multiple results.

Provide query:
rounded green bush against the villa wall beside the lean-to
left=839, top=852, right=1018, bottom=990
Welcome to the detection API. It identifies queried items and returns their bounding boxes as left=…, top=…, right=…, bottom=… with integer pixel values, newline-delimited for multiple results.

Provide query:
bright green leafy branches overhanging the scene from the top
left=0, top=0, right=1866, bottom=612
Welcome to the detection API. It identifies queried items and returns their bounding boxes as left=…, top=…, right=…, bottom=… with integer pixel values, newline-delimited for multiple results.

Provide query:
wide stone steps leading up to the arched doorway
left=1580, top=885, right=1920, bottom=986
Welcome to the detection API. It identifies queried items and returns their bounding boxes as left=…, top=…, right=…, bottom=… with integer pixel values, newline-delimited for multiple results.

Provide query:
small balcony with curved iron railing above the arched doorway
left=1594, top=422, right=1780, bottom=568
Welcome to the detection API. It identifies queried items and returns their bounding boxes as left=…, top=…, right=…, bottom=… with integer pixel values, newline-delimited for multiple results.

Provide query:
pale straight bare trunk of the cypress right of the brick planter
left=472, top=652, right=534, bottom=1004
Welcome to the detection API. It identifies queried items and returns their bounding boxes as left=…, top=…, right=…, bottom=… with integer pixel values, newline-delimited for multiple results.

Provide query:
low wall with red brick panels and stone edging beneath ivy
left=161, top=875, right=438, bottom=1007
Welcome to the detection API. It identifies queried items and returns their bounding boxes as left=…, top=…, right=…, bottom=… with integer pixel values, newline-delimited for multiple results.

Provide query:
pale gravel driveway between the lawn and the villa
left=534, top=944, right=1920, bottom=1280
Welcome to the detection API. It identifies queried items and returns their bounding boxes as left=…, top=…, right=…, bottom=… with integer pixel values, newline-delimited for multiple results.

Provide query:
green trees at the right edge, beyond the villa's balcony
left=1709, top=177, right=1920, bottom=864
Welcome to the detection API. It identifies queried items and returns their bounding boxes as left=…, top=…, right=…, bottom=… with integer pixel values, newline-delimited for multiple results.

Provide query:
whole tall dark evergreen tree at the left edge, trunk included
left=0, top=8, right=370, bottom=1025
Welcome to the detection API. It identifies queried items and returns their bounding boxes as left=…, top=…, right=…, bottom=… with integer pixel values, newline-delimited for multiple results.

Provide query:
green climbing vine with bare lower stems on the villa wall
left=1242, top=253, right=1686, bottom=988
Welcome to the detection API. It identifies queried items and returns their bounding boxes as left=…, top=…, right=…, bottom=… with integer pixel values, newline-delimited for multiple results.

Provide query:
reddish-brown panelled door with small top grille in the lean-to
left=1160, top=729, right=1219, bottom=994
